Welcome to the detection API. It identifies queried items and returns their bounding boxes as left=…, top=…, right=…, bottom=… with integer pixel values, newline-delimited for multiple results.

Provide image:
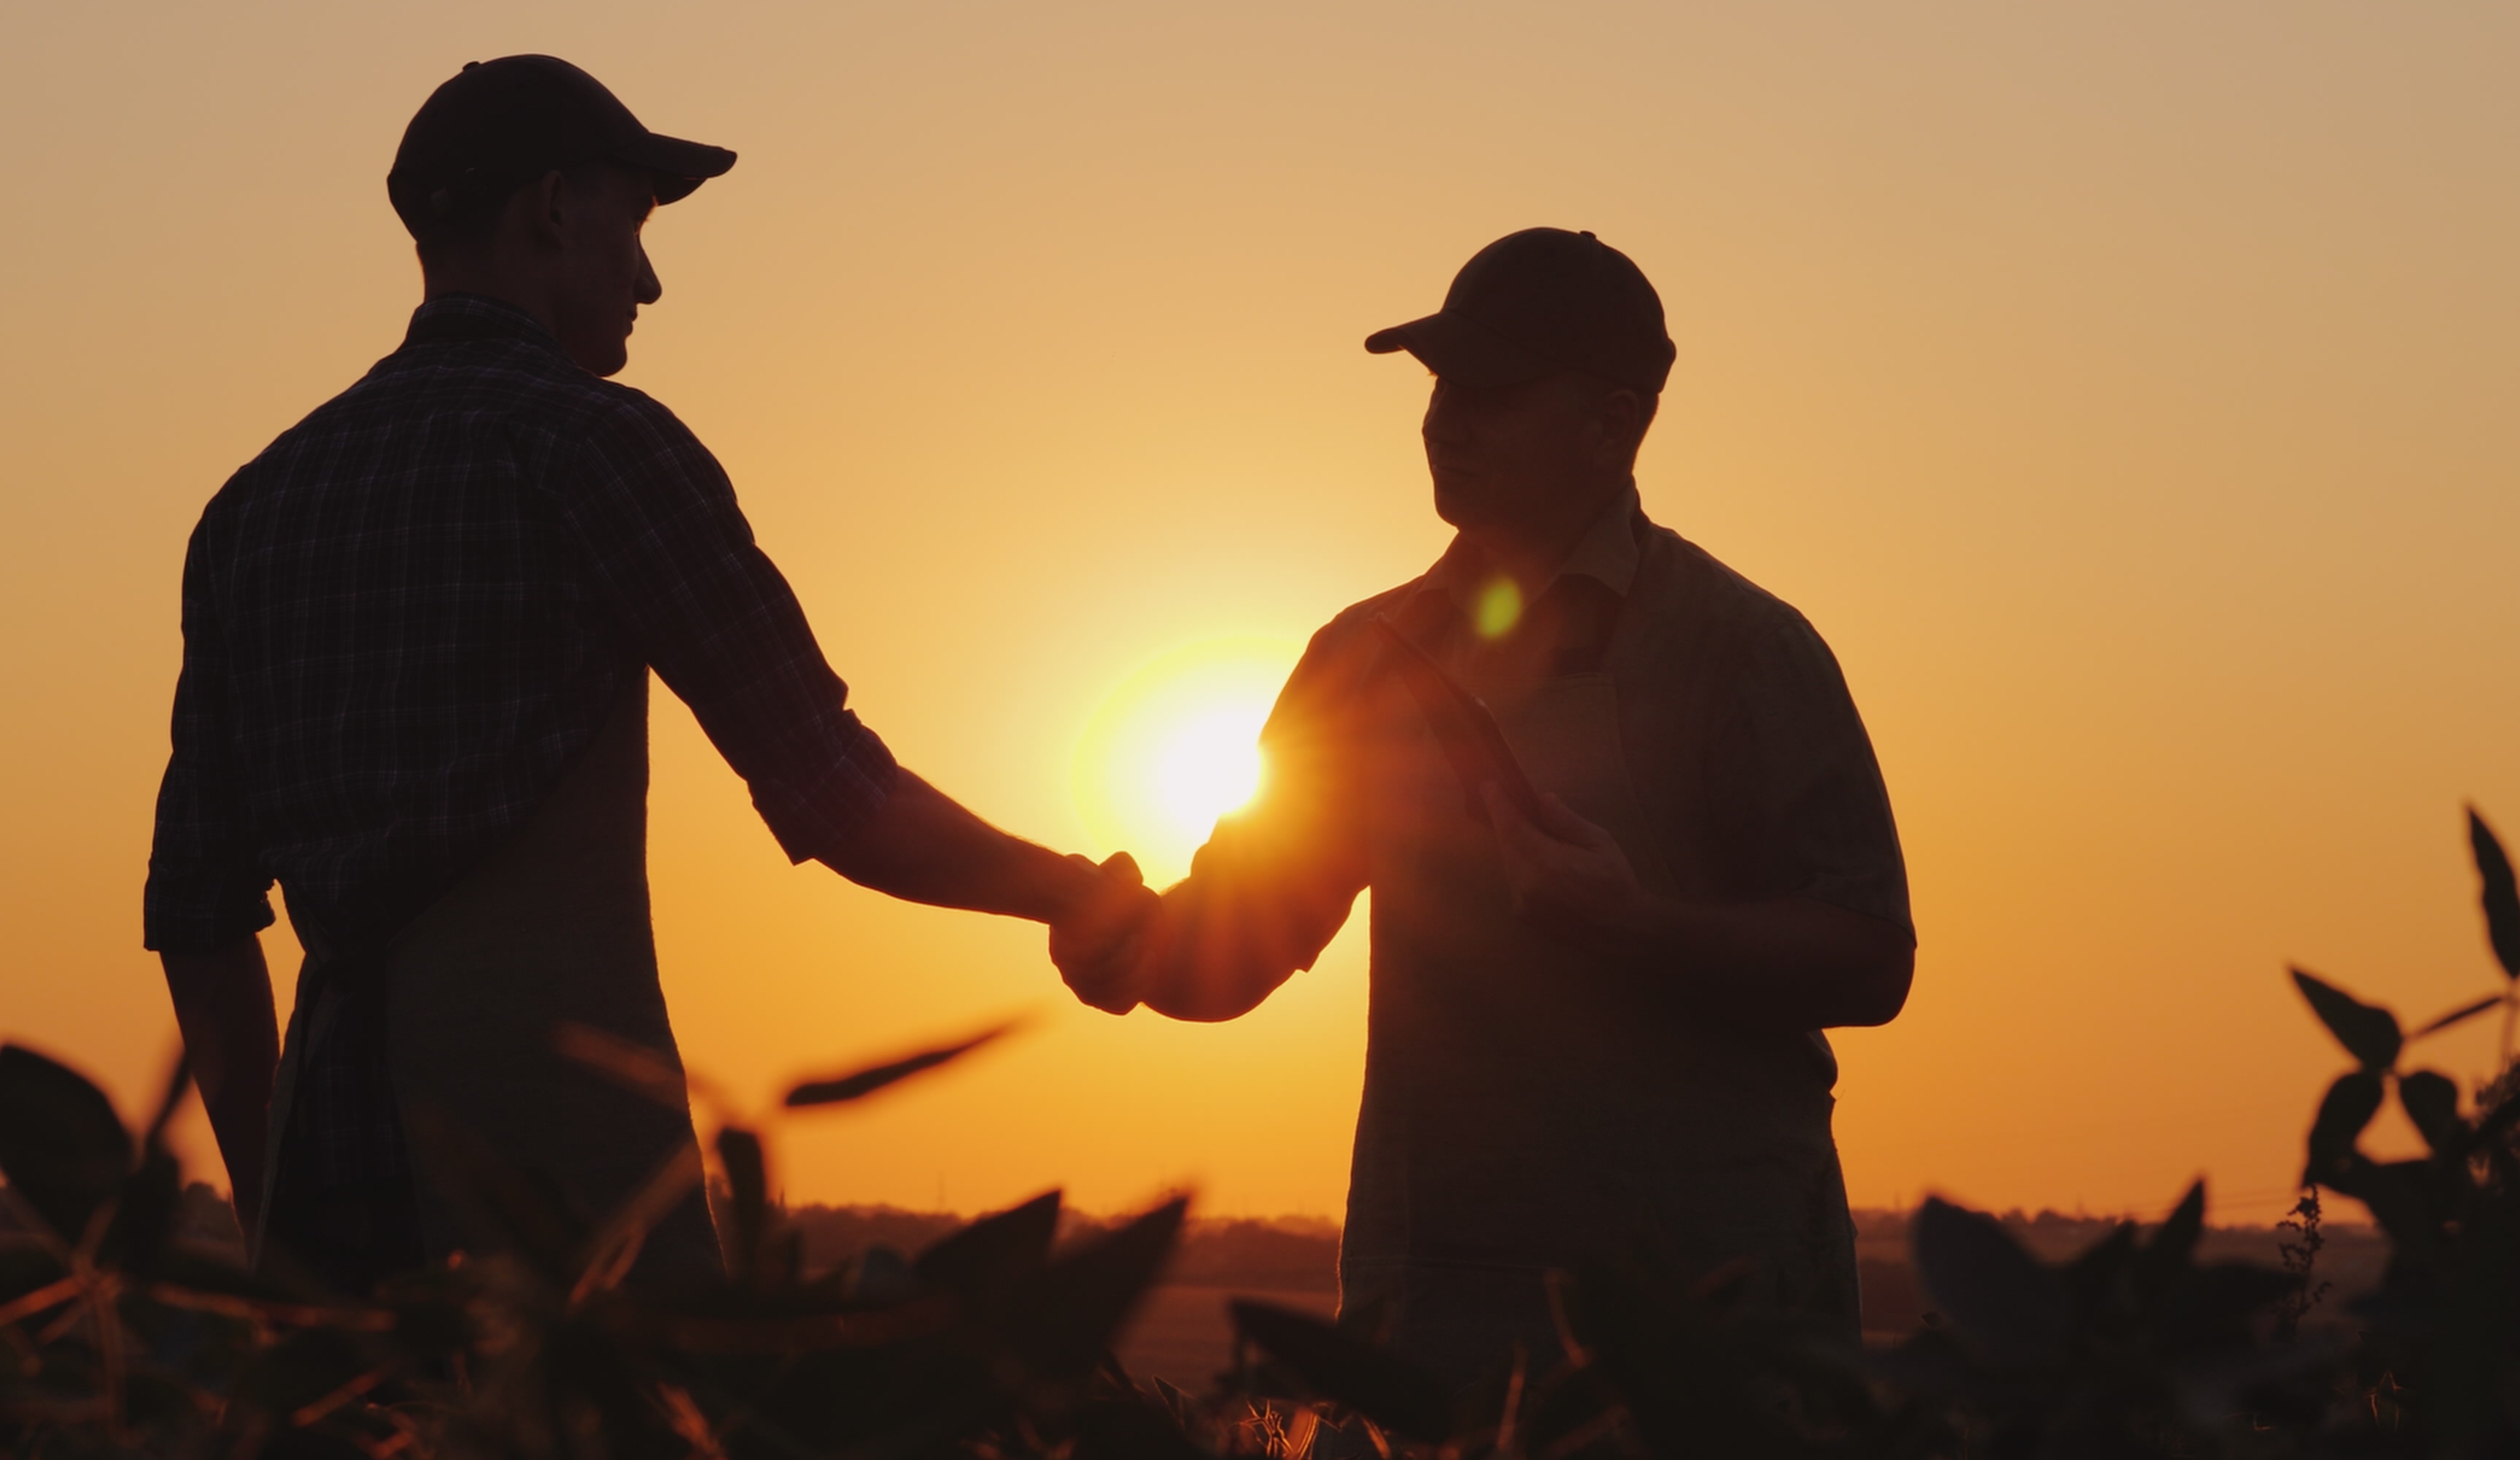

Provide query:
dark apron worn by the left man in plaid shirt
left=265, top=673, right=723, bottom=1281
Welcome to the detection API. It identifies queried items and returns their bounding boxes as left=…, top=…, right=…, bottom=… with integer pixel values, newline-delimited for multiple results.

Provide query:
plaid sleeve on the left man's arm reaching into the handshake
left=560, top=396, right=900, bottom=862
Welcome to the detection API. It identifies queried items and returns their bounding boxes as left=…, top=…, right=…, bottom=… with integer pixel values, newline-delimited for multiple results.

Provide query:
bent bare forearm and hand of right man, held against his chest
left=1487, top=787, right=1915, bottom=1034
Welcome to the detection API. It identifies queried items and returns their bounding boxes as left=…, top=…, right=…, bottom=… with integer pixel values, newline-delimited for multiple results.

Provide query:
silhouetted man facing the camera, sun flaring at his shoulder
left=1069, top=230, right=1915, bottom=1382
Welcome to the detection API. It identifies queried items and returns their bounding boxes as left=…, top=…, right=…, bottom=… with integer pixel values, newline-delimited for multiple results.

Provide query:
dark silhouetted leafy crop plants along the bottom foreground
left=0, top=814, right=2520, bottom=1460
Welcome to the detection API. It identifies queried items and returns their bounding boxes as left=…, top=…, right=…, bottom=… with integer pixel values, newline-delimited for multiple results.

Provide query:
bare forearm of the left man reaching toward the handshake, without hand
left=821, top=769, right=1097, bottom=923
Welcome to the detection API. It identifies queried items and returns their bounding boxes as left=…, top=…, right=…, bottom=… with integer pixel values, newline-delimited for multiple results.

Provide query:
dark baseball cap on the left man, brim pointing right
left=385, top=56, right=736, bottom=235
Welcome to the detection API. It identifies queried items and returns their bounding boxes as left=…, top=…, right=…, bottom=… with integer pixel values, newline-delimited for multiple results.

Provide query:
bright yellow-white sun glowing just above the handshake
left=1076, top=638, right=1298, bottom=883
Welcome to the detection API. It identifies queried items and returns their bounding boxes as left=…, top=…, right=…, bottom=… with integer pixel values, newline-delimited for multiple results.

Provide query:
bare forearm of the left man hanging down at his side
left=159, top=936, right=279, bottom=1230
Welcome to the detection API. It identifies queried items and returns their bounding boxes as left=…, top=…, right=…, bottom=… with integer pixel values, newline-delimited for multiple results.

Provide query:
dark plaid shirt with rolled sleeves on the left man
left=146, top=295, right=895, bottom=951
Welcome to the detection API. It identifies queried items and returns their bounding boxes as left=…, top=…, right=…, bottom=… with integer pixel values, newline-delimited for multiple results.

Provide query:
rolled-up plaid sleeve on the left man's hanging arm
left=141, top=524, right=272, bottom=953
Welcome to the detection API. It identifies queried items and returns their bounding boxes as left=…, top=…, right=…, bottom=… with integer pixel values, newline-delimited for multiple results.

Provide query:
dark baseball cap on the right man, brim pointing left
left=1366, top=227, right=1678, bottom=396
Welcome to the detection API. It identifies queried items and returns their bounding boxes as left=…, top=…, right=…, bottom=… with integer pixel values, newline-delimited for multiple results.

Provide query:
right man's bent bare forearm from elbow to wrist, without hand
left=1613, top=895, right=1915, bottom=1034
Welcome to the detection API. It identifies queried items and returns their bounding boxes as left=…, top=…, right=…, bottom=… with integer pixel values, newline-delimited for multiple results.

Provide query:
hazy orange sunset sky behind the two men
left=0, top=0, right=2520, bottom=1235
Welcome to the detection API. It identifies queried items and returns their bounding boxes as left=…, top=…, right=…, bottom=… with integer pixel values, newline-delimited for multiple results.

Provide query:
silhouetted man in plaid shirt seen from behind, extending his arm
left=146, top=56, right=1154, bottom=1289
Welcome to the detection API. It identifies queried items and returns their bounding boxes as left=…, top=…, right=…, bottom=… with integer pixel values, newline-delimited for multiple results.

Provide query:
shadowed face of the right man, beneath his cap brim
left=1421, top=376, right=1603, bottom=532
